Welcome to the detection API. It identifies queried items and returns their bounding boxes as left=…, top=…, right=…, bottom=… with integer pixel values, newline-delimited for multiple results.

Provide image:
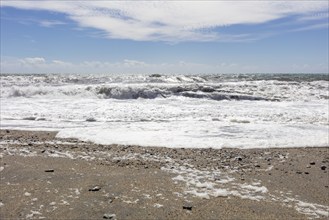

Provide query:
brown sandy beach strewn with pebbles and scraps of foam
left=0, top=130, right=329, bottom=219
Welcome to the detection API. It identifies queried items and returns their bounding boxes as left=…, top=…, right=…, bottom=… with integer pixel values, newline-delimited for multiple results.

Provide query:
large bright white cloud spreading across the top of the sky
left=1, top=0, right=329, bottom=42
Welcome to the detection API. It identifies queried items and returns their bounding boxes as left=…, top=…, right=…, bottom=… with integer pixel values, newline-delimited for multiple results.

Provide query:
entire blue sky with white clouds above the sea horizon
left=0, top=0, right=329, bottom=74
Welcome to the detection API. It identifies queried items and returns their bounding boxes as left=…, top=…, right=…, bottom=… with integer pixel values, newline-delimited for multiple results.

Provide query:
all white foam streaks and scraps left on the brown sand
left=0, top=138, right=329, bottom=218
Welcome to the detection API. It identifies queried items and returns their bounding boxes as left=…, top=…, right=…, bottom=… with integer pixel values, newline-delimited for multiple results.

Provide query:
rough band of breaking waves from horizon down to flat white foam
left=1, top=74, right=329, bottom=101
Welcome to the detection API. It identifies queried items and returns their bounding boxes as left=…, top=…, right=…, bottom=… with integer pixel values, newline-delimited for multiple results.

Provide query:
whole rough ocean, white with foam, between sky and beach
left=0, top=74, right=329, bottom=148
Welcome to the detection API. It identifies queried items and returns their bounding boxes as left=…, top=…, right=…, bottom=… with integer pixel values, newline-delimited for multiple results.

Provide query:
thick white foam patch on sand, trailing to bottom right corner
left=162, top=163, right=329, bottom=218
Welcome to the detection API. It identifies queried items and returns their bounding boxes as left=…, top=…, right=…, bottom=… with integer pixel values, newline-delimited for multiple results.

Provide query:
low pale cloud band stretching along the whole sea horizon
left=0, top=57, right=329, bottom=74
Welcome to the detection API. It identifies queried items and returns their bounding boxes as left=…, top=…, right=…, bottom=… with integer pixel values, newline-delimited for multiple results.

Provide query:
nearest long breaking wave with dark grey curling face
left=1, top=86, right=279, bottom=101
